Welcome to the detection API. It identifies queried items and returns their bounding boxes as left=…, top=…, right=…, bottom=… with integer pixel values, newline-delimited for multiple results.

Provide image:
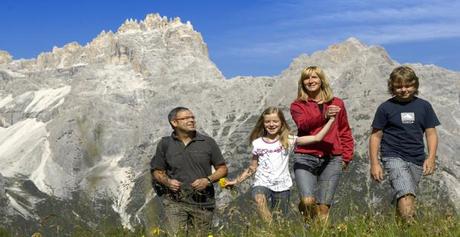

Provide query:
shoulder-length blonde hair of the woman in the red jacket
left=297, top=66, right=334, bottom=103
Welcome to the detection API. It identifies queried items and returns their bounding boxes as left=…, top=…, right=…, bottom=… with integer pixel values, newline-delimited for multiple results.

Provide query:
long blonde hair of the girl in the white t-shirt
left=249, top=106, right=291, bottom=149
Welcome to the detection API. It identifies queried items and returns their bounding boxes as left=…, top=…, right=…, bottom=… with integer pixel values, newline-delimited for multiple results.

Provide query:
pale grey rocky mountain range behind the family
left=0, top=14, right=460, bottom=234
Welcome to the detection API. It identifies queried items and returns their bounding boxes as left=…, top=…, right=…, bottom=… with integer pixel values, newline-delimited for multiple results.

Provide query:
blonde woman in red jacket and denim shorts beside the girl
left=291, top=66, right=353, bottom=221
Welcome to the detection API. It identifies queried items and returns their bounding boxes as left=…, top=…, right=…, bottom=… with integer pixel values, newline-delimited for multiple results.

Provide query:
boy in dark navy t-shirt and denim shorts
left=369, top=66, right=440, bottom=221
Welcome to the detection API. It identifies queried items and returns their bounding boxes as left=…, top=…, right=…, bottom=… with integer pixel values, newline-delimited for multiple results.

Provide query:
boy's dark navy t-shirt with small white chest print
left=372, top=97, right=440, bottom=165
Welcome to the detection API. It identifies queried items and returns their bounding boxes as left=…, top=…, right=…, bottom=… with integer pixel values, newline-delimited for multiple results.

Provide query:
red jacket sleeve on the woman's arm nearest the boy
left=337, top=104, right=354, bottom=163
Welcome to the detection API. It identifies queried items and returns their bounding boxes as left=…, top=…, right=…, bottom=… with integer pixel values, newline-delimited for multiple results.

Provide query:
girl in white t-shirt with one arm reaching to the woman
left=225, top=107, right=335, bottom=223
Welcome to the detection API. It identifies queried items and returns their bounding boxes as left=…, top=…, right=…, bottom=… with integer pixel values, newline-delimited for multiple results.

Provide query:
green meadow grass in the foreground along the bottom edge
left=0, top=208, right=460, bottom=237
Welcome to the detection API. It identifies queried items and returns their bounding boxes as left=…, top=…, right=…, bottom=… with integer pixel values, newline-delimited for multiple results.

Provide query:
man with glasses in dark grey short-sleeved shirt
left=150, top=107, right=227, bottom=235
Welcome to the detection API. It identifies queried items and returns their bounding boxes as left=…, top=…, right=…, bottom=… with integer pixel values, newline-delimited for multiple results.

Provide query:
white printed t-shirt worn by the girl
left=252, top=136, right=297, bottom=192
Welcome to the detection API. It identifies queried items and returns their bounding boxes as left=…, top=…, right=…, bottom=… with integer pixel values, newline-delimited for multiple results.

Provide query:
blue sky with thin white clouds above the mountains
left=0, top=0, right=460, bottom=78
